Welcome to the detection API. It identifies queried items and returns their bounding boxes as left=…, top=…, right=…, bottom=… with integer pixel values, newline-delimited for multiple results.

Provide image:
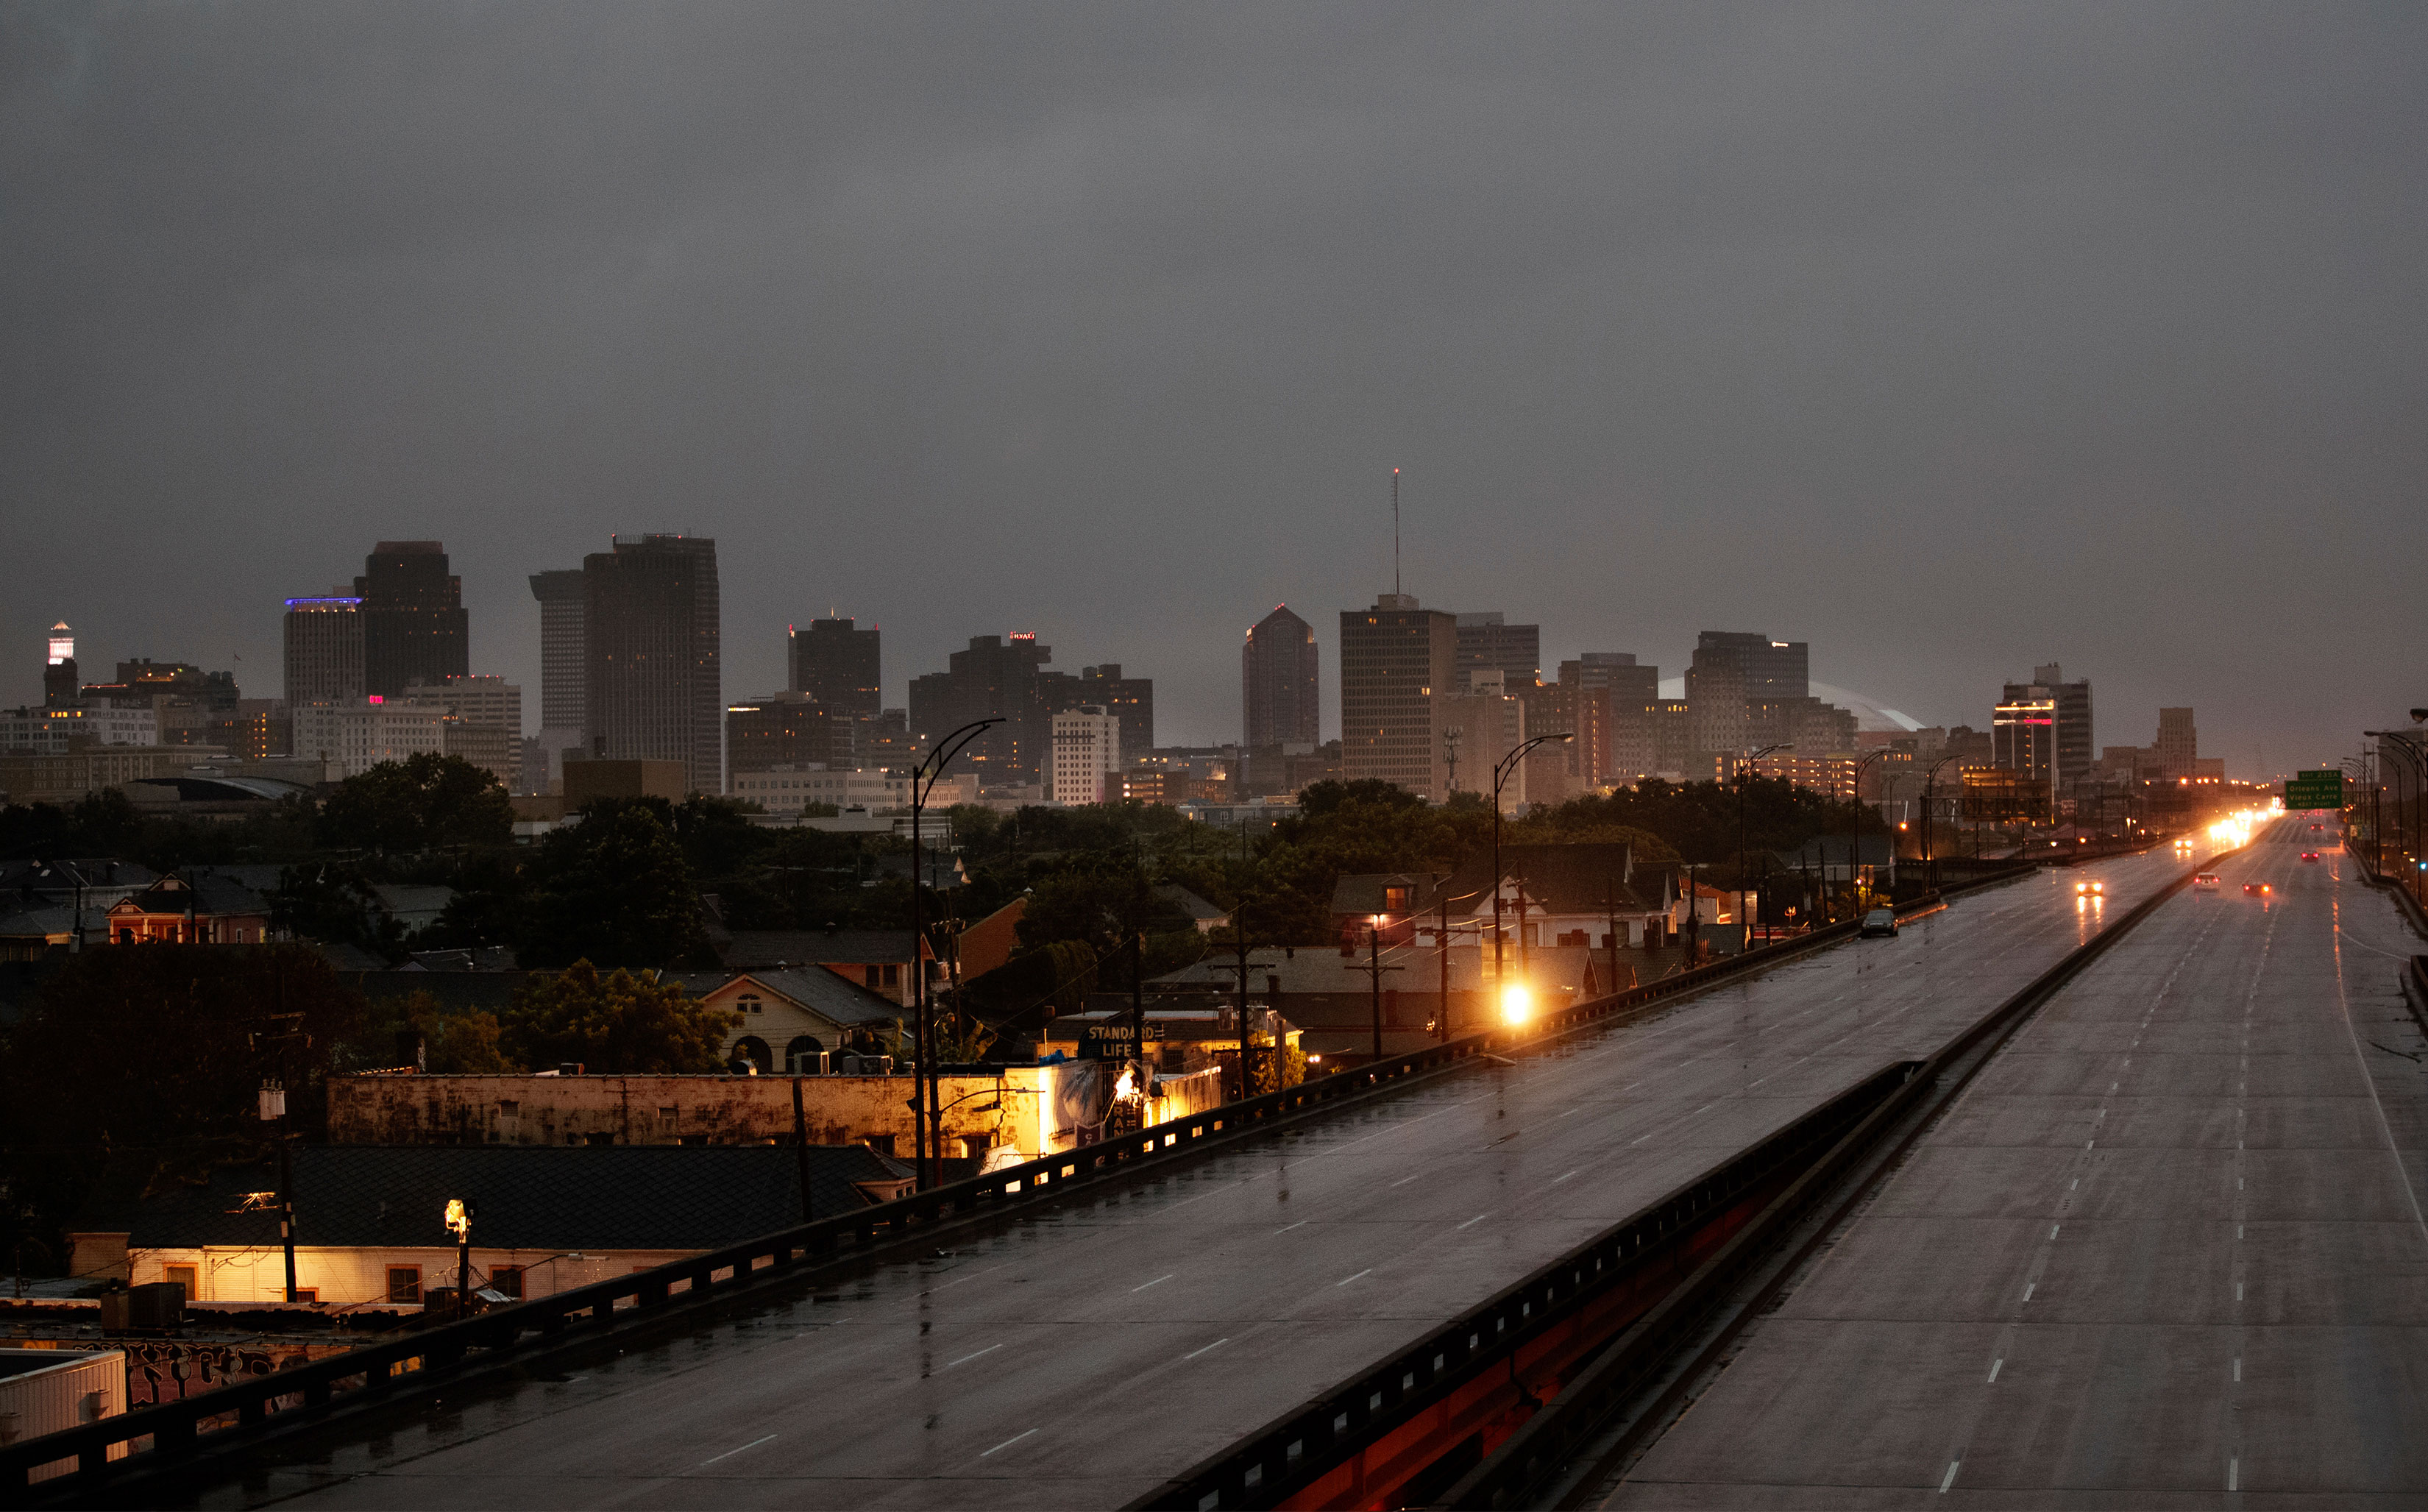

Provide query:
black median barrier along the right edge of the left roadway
left=1129, top=1060, right=1920, bottom=1512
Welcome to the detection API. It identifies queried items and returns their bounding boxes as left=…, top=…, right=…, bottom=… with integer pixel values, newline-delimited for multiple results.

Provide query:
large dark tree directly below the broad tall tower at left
left=515, top=798, right=717, bottom=966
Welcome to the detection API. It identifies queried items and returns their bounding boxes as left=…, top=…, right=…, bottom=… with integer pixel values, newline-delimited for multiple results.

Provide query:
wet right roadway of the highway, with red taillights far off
left=1595, top=818, right=2428, bottom=1507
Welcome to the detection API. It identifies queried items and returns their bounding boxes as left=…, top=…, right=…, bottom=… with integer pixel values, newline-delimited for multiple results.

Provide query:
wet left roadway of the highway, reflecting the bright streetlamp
left=223, top=854, right=2183, bottom=1507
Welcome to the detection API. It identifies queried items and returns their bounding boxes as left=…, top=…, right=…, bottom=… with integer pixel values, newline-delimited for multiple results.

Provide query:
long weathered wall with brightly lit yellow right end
left=328, top=1065, right=1068, bottom=1157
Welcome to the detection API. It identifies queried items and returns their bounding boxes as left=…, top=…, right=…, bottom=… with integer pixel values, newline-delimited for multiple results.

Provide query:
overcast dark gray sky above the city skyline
left=0, top=0, right=2428, bottom=777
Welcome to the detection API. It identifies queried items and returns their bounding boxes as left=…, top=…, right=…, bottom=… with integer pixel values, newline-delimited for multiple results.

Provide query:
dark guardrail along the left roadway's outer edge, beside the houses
left=0, top=864, right=2032, bottom=1505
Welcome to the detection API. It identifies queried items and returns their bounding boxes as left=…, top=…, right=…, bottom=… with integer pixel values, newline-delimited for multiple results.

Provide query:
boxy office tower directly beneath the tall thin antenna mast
left=1341, top=592, right=1446, bottom=803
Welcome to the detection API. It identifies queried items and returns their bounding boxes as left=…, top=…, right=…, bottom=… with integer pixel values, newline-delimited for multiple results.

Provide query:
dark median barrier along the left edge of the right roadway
left=1435, top=852, right=2232, bottom=1510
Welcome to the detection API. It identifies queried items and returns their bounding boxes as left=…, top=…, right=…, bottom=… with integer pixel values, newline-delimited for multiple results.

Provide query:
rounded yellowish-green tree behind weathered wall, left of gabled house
left=498, top=961, right=741, bottom=1075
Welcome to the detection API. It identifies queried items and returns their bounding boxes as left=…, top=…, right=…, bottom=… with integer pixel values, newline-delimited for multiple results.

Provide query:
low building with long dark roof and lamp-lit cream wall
left=68, top=1145, right=908, bottom=1310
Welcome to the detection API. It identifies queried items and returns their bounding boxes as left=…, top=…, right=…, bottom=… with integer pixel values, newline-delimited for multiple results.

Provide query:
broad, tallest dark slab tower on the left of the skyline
left=583, top=534, right=726, bottom=794
